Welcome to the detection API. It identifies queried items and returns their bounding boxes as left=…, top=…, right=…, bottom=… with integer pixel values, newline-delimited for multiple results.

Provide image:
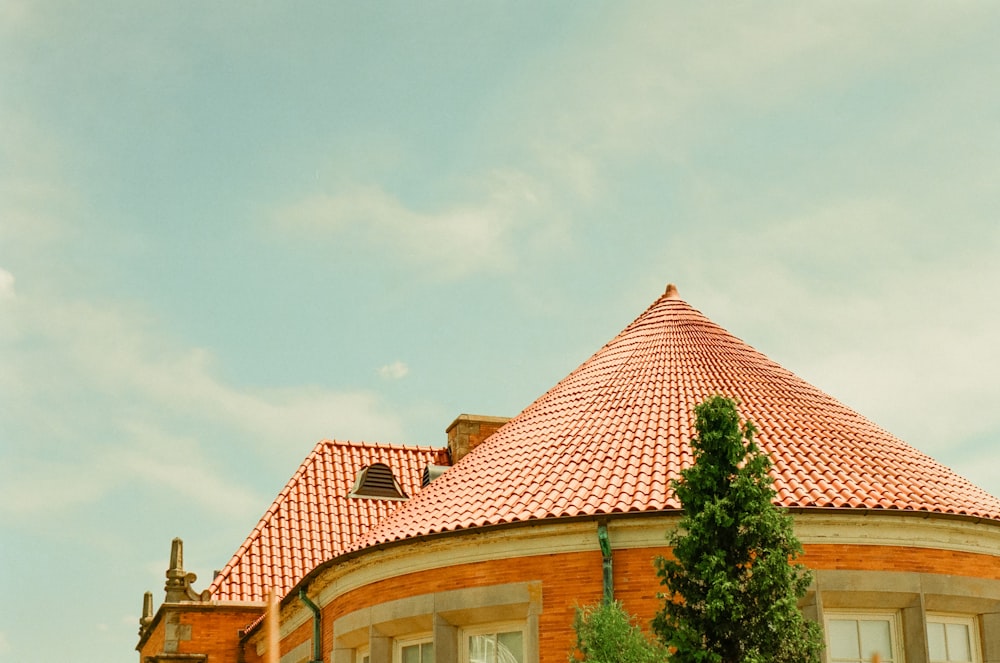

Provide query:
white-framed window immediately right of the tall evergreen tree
left=826, top=612, right=903, bottom=663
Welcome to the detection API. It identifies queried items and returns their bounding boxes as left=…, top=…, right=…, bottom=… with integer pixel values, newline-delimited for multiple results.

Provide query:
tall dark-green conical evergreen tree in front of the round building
left=653, top=396, right=823, bottom=663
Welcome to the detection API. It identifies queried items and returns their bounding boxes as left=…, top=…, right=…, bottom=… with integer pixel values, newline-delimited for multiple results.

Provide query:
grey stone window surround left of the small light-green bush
left=331, top=582, right=542, bottom=663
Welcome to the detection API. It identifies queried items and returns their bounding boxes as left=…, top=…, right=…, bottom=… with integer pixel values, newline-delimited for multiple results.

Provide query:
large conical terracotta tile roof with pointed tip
left=351, top=288, right=1000, bottom=549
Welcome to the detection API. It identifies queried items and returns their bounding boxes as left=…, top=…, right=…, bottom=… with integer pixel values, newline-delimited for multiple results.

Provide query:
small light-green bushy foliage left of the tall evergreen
left=569, top=601, right=667, bottom=663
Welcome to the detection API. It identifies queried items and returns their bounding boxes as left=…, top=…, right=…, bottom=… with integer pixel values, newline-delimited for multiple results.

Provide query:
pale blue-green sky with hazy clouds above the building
left=0, top=0, right=1000, bottom=663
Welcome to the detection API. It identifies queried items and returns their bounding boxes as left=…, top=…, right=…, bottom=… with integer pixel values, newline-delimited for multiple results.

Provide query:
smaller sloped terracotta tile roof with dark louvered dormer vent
left=209, top=440, right=446, bottom=601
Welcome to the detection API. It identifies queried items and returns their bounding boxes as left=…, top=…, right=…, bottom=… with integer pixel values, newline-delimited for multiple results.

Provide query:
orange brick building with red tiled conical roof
left=137, top=286, right=1000, bottom=663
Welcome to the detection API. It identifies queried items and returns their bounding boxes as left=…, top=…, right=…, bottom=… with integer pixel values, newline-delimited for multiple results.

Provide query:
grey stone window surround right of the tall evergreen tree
left=802, top=570, right=1000, bottom=663
